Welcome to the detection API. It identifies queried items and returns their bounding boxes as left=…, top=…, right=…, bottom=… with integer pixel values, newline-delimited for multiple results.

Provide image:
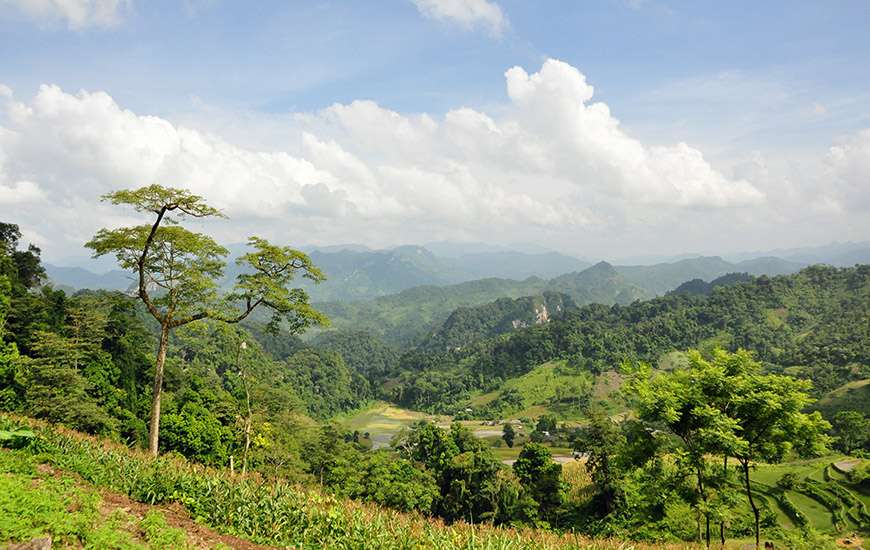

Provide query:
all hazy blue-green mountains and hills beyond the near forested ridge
left=46, top=242, right=870, bottom=346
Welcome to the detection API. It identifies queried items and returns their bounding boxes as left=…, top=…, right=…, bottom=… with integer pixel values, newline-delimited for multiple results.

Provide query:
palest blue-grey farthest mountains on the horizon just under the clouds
left=46, top=242, right=870, bottom=302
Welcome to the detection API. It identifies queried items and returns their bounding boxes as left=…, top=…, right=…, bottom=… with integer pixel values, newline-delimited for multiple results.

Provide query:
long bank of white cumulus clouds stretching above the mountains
left=0, top=60, right=870, bottom=260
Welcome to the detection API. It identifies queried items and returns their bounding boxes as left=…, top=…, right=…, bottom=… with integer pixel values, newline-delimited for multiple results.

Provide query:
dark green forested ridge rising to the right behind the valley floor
left=384, top=265, right=870, bottom=411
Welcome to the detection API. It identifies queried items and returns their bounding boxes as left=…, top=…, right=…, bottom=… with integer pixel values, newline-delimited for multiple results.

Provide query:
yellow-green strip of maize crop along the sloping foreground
left=0, top=415, right=697, bottom=550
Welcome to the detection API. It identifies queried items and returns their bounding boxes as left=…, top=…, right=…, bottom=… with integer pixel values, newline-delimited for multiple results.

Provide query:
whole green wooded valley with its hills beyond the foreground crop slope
left=0, top=217, right=870, bottom=547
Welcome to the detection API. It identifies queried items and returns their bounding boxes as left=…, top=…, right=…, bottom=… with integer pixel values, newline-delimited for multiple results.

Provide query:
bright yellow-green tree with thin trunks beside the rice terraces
left=628, top=350, right=830, bottom=546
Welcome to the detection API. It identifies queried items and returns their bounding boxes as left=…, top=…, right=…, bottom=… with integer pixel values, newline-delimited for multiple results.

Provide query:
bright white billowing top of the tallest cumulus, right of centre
left=505, top=59, right=764, bottom=207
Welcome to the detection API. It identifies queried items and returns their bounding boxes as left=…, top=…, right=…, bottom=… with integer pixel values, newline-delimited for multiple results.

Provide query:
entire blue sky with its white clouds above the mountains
left=0, top=0, right=870, bottom=263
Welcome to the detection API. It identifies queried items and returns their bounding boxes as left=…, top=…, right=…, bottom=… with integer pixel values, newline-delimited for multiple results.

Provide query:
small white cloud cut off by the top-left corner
left=0, top=0, right=132, bottom=30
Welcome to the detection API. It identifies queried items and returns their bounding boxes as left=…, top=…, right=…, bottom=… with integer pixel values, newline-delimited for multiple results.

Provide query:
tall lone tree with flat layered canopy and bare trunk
left=85, top=185, right=328, bottom=456
